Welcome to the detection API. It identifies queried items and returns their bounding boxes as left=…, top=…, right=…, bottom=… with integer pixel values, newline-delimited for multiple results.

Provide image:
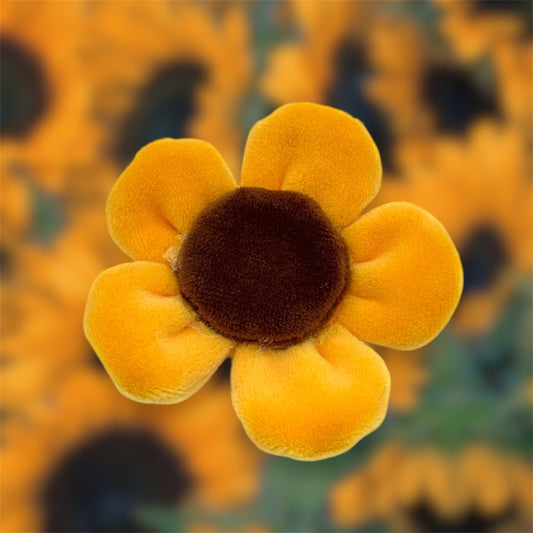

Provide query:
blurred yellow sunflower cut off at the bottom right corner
left=329, top=442, right=533, bottom=533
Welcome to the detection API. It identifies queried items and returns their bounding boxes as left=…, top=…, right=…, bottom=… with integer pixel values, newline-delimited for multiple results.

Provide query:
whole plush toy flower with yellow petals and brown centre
left=84, top=103, right=462, bottom=460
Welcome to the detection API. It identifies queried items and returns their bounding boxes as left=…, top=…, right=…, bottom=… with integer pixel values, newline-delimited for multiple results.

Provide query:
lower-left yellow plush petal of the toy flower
left=85, top=261, right=232, bottom=403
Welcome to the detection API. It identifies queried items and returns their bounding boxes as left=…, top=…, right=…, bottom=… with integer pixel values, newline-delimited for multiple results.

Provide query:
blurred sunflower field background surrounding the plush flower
left=0, top=0, right=533, bottom=533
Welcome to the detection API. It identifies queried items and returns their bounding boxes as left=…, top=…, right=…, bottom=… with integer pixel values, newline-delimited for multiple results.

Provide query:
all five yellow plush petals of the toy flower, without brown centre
left=84, top=103, right=462, bottom=460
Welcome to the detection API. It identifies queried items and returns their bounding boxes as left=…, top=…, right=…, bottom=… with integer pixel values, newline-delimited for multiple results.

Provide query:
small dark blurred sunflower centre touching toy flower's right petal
left=460, top=226, right=508, bottom=294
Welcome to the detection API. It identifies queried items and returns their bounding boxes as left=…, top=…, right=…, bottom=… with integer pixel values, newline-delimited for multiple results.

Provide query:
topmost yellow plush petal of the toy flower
left=242, top=103, right=381, bottom=227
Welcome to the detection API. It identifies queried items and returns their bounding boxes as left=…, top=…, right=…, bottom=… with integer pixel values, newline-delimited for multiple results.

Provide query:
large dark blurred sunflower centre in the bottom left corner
left=42, top=428, right=191, bottom=532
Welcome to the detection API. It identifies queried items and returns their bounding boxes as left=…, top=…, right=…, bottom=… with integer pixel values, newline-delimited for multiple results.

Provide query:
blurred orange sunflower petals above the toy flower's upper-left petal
left=83, top=0, right=253, bottom=176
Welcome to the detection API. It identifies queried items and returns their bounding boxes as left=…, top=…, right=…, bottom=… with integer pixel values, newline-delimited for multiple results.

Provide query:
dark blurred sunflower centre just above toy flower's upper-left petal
left=116, top=61, right=207, bottom=163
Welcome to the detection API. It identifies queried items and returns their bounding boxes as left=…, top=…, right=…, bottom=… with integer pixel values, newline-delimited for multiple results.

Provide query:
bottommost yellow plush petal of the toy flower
left=231, top=325, right=390, bottom=461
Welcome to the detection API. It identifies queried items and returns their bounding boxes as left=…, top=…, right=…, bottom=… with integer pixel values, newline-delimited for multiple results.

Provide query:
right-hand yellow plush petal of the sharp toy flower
left=335, top=202, right=463, bottom=350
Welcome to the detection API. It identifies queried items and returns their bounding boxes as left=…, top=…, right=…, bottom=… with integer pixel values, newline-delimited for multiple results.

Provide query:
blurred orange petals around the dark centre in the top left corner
left=0, top=0, right=98, bottom=192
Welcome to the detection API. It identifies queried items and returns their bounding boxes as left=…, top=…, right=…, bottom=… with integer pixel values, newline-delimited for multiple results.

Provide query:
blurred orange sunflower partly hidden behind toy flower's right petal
left=377, top=122, right=533, bottom=334
